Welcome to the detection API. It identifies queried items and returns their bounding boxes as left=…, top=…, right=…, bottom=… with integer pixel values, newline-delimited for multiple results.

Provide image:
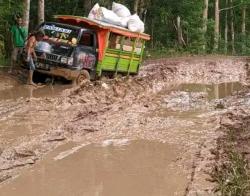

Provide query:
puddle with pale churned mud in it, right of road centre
left=157, top=82, right=244, bottom=117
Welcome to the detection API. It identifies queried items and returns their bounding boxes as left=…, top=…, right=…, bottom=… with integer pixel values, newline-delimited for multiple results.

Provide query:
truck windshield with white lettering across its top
left=41, top=23, right=80, bottom=45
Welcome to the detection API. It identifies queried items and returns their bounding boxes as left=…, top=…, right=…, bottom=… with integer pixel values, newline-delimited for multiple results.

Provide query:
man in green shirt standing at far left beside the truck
left=9, top=17, right=28, bottom=72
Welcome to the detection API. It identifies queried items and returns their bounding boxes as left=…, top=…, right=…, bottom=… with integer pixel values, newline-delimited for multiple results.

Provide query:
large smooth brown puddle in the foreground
left=0, top=141, right=188, bottom=196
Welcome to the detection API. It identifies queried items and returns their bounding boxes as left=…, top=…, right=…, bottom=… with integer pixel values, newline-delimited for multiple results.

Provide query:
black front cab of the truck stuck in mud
left=35, top=22, right=98, bottom=80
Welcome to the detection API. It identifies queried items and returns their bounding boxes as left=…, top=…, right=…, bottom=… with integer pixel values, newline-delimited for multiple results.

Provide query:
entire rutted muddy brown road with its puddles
left=0, top=57, right=250, bottom=196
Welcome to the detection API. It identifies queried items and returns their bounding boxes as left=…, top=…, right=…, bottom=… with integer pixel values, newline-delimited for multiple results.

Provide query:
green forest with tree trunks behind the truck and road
left=0, top=0, right=250, bottom=57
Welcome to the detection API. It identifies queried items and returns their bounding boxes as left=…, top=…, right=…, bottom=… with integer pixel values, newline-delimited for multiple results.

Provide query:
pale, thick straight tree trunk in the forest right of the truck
left=214, top=0, right=220, bottom=51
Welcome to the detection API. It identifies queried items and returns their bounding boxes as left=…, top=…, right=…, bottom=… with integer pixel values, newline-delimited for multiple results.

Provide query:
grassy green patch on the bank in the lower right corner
left=211, top=130, right=250, bottom=196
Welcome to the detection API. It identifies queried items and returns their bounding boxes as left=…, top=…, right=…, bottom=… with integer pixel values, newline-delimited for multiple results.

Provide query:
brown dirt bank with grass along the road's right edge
left=211, top=90, right=250, bottom=195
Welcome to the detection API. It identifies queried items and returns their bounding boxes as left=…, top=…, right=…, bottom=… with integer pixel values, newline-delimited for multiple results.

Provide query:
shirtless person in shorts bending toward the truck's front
left=25, top=30, right=45, bottom=86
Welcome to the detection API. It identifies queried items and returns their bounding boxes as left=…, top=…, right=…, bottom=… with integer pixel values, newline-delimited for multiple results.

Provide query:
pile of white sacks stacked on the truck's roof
left=88, top=2, right=144, bottom=33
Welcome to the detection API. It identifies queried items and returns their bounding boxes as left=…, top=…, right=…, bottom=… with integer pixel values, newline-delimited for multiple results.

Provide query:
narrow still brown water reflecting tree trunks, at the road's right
left=178, top=82, right=243, bottom=100
